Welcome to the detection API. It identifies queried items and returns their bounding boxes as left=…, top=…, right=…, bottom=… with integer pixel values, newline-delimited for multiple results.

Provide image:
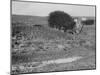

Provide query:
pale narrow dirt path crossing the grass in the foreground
left=12, top=56, right=83, bottom=70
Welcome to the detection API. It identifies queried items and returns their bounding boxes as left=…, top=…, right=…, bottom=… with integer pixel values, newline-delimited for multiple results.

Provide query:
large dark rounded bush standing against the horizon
left=48, top=11, right=75, bottom=31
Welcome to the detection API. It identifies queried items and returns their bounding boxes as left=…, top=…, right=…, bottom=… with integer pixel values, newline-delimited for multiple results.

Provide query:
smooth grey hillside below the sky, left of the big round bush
left=12, top=15, right=48, bottom=25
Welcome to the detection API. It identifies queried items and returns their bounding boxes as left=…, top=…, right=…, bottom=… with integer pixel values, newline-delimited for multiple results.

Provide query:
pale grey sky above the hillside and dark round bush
left=12, top=1, right=95, bottom=17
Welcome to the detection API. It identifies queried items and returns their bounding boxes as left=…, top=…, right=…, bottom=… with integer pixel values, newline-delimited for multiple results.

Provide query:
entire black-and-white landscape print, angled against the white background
left=10, top=0, right=96, bottom=75
